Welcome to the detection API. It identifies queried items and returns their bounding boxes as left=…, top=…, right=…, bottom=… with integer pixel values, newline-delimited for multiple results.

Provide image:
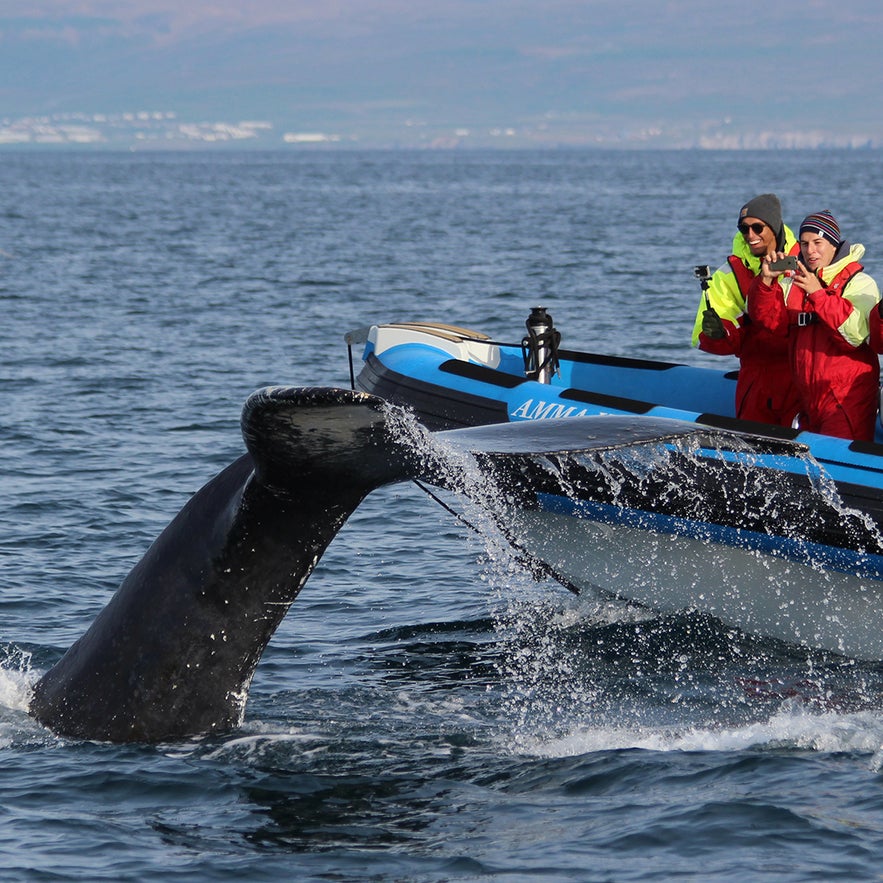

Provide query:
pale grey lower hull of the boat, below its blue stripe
left=508, top=510, right=883, bottom=659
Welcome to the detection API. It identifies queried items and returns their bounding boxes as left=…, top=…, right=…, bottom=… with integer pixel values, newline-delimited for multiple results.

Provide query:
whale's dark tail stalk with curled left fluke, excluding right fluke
left=30, top=388, right=406, bottom=742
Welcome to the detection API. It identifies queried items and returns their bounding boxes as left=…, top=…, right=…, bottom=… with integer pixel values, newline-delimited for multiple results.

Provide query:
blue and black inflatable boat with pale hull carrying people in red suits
left=355, top=325, right=883, bottom=659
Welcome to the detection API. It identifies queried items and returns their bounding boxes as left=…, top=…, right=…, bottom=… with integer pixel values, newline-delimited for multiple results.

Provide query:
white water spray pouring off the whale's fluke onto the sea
left=382, top=411, right=883, bottom=757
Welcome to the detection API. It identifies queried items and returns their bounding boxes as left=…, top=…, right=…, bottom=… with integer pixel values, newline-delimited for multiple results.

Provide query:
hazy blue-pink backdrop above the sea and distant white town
left=0, top=0, right=883, bottom=147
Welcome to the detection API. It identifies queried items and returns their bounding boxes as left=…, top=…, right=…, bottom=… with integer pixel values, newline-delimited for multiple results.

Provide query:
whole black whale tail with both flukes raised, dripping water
left=30, top=387, right=816, bottom=742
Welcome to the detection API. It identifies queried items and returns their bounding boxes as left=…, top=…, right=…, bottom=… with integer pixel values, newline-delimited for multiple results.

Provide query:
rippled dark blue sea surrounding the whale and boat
left=0, top=151, right=883, bottom=883
